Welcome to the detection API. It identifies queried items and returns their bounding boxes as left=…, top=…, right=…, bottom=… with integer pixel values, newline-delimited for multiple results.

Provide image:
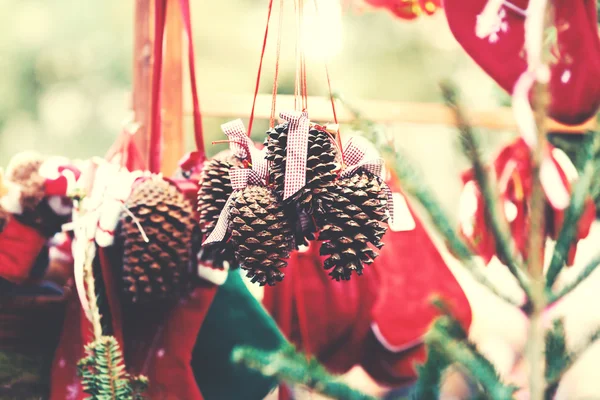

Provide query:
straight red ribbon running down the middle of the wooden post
left=148, top=0, right=167, bottom=173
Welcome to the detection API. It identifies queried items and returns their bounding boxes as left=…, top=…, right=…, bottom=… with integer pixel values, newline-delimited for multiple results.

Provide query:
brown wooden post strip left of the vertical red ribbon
left=132, top=0, right=154, bottom=167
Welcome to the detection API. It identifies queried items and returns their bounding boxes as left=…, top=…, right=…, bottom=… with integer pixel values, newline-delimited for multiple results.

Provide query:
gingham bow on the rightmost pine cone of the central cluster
left=340, top=136, right=394, bottom=222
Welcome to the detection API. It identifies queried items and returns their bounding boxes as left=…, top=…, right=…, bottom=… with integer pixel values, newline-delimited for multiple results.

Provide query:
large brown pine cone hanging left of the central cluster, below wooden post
left=120, top=177, right=194, bottom=303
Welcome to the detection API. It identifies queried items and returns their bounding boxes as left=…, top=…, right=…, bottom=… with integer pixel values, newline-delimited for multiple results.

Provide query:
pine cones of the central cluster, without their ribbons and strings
left=192, top=123, right=388, bottom=286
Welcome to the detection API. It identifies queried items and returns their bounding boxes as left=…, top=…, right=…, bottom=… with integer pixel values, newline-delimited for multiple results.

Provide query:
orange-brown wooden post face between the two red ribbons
left=161, top=0, right=185, bottom=176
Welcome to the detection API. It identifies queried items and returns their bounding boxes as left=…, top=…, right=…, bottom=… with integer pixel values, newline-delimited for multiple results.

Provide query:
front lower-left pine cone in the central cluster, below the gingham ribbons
left=230, top=185, right=293, bottom=286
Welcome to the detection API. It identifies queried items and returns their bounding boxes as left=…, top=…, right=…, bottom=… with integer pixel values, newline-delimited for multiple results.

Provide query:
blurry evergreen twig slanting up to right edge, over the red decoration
left=546, top=134, right=600, bottom=288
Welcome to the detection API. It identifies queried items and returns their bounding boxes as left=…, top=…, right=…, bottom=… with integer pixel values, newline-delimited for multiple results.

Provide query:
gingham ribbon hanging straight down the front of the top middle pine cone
left=279, top=111, right=310, bottom=200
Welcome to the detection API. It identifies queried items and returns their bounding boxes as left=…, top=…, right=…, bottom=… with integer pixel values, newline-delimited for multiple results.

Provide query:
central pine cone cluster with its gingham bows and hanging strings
left=199, top=0, right=392, bottom=286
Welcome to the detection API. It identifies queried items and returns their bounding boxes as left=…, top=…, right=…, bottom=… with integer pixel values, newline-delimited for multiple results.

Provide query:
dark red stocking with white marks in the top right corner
left=444, top=0, right=600, bottom=124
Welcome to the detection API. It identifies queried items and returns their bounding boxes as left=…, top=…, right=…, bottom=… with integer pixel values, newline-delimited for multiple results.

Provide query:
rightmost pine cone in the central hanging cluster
left=319, top=171, right=388, bottom=281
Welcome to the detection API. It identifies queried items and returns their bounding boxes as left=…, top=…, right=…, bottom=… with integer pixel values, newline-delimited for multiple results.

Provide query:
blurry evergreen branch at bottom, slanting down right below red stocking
left=425, top=315, right=517, bottom=400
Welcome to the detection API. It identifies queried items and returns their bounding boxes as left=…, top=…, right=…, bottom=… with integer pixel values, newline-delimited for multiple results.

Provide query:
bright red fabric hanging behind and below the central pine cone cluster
left=263, top=173, right=471, bottom=385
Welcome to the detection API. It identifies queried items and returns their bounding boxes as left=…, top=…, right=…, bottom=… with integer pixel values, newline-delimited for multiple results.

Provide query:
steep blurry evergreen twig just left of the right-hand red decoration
left=440, top=82, right=531, bottom=299
